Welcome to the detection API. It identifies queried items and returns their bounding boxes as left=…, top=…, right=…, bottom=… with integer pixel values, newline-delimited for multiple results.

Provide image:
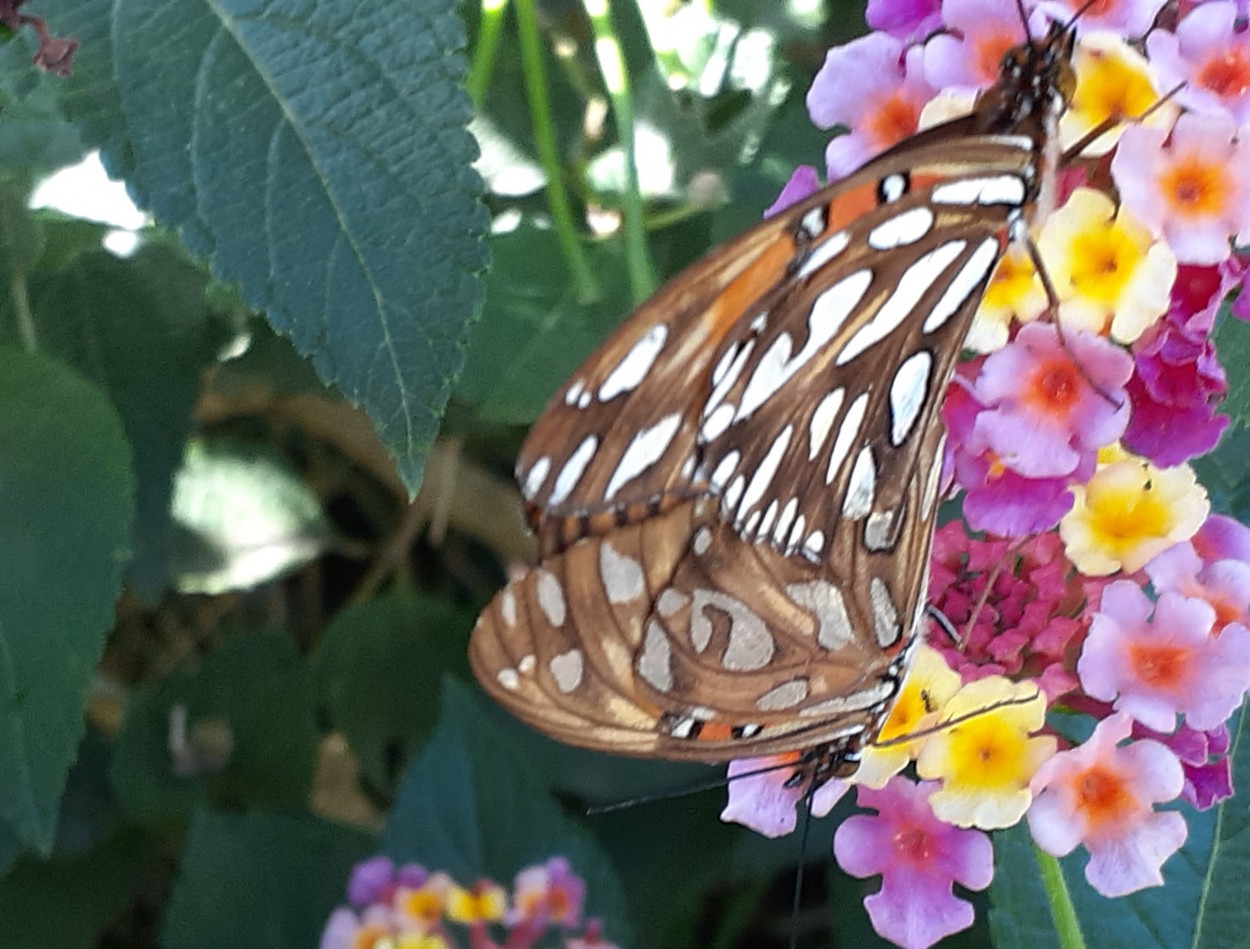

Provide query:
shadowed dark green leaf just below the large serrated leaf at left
left=15, top=246, right=226, bottom=599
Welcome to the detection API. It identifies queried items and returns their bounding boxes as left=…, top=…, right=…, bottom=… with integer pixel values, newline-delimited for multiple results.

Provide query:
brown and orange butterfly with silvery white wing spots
left=470, top=14, right=1074, bottom=784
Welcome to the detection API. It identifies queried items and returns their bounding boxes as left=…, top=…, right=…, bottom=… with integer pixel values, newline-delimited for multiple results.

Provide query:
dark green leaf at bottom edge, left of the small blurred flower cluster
left=161, top=811, right=375, bottom=949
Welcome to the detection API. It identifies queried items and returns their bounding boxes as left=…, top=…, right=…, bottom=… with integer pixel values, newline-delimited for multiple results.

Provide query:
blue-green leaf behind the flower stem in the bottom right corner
left=990, top=700, right=1250, bottom=949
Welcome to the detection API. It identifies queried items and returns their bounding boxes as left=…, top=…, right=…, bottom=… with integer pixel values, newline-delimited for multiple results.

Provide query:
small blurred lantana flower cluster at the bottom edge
left=320, top=856, right=618, bottom=949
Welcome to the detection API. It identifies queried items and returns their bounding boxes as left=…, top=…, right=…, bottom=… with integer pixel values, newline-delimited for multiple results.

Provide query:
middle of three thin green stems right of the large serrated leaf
left=516, top=0, right=599, bottom=303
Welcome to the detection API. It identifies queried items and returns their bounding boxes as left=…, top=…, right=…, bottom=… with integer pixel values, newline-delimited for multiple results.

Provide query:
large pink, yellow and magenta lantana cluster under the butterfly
left=723, top=0, right=1250, bottom=948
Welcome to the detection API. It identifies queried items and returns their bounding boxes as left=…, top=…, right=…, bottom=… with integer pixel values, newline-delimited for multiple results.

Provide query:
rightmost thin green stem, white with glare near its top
left=583, top=0, right=655, bottom=304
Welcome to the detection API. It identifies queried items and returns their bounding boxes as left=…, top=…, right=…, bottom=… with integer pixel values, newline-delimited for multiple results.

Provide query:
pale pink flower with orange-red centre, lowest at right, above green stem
left=1029, top=714, right=1188, bottom=896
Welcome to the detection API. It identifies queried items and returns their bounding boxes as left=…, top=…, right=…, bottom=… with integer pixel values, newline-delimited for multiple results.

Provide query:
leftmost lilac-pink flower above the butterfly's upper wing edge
left=808, top=33, right=934, bottom=180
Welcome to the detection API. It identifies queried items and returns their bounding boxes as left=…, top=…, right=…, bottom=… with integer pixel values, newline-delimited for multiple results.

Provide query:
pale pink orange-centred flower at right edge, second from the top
left=1111, top=114, right=1250, bottom=264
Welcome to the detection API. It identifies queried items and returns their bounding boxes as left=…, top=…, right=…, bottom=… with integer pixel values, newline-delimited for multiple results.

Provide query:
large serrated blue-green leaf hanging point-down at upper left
left=40, top=0, right=486, bottom=490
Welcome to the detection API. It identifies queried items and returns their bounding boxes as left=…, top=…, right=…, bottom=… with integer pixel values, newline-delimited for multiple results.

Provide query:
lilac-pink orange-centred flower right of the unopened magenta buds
left=1076, top=580, right=1250, bottom=731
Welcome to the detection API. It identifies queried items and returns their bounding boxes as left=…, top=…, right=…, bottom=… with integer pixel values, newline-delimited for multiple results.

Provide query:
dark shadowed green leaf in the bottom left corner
left=0, top=833, right=158, bottom=949
